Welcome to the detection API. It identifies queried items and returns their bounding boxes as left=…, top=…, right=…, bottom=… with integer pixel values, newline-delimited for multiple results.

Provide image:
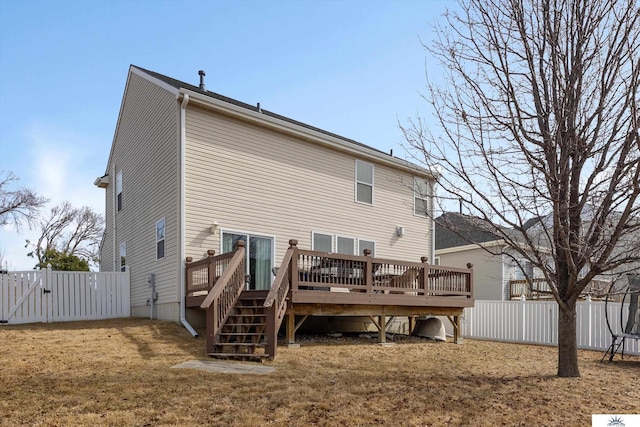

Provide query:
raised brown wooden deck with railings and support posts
left=185, top=240, right=473, bottom=357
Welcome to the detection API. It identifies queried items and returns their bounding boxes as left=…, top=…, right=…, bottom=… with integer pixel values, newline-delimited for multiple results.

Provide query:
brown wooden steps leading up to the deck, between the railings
left=208, top=291, right=269, bottom=360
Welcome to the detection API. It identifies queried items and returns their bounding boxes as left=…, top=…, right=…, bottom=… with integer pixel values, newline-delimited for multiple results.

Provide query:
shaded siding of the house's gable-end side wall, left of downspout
left=102, top=73, right=180, bottom=320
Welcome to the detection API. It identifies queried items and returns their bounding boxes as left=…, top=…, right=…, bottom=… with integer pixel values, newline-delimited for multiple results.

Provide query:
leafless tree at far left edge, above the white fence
left=0, top=171, right=47, bottom=229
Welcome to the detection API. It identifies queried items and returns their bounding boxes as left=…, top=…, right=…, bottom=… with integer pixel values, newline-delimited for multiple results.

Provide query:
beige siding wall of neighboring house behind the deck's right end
left=436, top=248, right=508, bottom=300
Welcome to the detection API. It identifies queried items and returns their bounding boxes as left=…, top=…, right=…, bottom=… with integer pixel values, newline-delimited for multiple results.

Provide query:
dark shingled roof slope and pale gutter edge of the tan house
left=131, top=65, right=430, bottom=179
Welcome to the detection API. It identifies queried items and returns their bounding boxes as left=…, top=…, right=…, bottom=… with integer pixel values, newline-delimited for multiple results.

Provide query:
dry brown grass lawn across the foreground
left=0, top=319, right=640, bottom=426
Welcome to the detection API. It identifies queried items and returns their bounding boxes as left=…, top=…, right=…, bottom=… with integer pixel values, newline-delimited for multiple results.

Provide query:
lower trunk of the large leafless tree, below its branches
left=558, top=303, right=580, bottom=377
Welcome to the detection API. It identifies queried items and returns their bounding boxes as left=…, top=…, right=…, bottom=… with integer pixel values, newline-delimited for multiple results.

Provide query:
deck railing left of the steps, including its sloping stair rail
left=186, top=240, right=245, bottom=352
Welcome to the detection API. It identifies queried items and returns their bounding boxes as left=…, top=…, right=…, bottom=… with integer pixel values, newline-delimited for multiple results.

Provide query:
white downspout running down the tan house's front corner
left=178, top=93, right=198, bottom=337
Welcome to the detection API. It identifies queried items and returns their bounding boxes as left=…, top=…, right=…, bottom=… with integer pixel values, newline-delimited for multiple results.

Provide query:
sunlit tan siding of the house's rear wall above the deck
left=185, top=106, right=431, bottom=264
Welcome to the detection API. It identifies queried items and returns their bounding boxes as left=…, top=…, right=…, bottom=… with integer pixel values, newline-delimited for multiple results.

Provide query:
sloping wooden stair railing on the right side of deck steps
left=264, top=239, right=298, bottom=359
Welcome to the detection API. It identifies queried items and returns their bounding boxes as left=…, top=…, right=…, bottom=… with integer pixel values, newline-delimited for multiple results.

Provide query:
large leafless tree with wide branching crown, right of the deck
left=403, top=0, right=640, bottom=377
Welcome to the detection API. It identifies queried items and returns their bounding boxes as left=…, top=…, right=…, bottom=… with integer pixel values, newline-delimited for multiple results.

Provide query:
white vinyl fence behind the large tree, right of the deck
left=462, top=300, right=640, bottom=356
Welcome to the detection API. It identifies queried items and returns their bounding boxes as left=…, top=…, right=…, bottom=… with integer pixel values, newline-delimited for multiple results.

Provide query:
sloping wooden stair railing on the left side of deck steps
left=200, top=240, right=245, bottom=352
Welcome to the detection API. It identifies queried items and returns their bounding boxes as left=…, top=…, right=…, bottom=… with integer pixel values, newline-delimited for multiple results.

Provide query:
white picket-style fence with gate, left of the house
left=0, top=269, right=131, bottom=324
